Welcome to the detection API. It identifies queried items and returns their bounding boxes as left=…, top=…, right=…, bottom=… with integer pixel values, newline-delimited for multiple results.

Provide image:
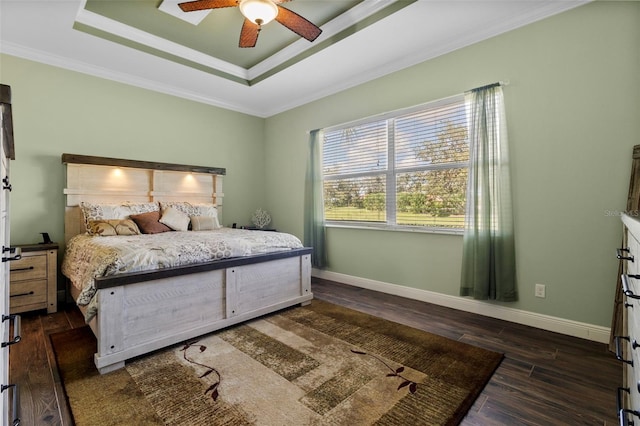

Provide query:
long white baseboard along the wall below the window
left=311, top=268, right=611, bottom=343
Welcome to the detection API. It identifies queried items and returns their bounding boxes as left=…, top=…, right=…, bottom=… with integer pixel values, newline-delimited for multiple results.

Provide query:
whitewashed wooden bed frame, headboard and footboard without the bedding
left=62, top=154, right=313, bottom=373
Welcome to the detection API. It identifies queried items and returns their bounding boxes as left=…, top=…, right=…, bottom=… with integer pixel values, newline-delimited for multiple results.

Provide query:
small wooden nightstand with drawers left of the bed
left=9, top=243, right=58, bottom=314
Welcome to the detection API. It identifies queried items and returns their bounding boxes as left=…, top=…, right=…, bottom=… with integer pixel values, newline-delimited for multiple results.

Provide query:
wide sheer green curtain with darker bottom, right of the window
left=460, top=84, right=518, bottom=302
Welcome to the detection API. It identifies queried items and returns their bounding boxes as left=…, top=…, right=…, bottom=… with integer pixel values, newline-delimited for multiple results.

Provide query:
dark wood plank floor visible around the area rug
left=10, top=279, right=622, bottom=426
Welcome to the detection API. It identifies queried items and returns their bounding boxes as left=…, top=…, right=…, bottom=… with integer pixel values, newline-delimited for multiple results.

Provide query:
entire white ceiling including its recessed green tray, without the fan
left=0, top=0, right=588, bottom=117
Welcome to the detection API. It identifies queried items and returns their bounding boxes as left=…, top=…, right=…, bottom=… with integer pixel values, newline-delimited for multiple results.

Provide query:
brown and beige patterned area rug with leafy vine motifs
left=51, top=300, right=502, bottom=426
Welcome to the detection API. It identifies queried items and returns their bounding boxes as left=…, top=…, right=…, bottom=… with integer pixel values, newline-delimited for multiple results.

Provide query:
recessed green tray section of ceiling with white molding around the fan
left=74, top=0, right=400, bottom=85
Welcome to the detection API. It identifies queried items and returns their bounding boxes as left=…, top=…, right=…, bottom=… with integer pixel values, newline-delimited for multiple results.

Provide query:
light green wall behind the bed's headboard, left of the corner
left=0, top=55, right=265, bottom=248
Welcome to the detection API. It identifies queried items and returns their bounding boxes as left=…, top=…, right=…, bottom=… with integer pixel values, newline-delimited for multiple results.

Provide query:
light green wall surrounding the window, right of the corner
left=265, top=2, right=640, bottom=326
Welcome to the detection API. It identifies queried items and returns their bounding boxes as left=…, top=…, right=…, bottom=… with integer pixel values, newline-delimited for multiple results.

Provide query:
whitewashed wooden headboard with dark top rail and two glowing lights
left=62, top=154, right=226, bottom=242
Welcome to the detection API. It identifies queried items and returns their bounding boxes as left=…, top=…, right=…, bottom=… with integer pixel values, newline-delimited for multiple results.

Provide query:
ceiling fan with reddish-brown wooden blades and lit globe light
left=178, top=0, right=322, bottom=47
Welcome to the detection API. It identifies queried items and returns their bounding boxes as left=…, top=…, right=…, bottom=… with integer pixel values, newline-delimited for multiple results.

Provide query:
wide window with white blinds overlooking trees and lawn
left=322, top=95, right=469, bottom=230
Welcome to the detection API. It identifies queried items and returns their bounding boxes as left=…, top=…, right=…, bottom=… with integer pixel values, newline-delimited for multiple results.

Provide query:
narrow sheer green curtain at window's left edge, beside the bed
left=304, top=130, right=327, bottom=268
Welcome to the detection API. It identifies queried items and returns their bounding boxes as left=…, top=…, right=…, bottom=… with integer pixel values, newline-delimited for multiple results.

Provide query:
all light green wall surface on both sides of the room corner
left=0, top=2, right=640, bottom=326
